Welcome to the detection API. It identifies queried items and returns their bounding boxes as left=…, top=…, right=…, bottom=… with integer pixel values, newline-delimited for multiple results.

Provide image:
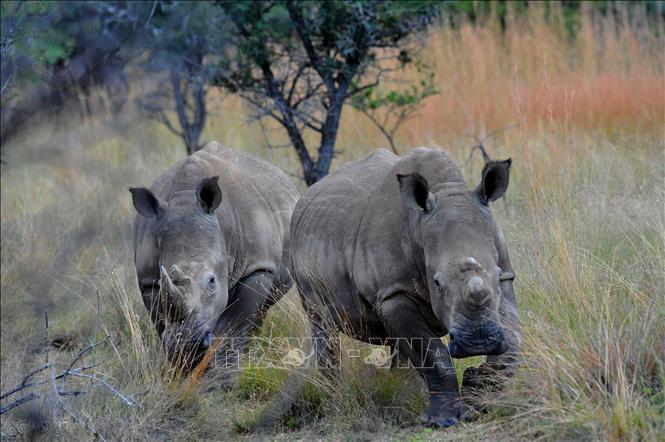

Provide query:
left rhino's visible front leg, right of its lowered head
left=213, top=271, right=288, bottom=388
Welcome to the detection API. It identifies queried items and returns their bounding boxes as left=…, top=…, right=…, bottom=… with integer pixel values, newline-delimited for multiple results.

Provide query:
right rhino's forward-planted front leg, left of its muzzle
left=380, top=295, right=470, bottom=427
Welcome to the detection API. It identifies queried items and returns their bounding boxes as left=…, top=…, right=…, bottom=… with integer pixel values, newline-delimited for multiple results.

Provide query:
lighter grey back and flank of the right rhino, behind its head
left=291, top=148, right=464, bottom=304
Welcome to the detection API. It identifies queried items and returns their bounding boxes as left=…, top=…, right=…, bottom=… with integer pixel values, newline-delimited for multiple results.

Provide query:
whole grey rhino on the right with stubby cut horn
left=291, top=148, right=520, bottom=426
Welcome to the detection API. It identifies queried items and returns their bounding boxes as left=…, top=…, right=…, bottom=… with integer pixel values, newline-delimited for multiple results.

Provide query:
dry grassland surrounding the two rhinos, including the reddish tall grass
left=0, top=2, right=665, bottom=440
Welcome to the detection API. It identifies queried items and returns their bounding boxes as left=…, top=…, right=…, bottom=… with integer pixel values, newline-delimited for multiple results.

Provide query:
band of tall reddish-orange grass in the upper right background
left=394, top=3, right=665, bottom=139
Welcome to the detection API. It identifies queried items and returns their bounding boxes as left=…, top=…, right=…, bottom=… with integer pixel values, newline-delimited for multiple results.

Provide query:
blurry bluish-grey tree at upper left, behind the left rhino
left=100, top=1, right=223, bottom=154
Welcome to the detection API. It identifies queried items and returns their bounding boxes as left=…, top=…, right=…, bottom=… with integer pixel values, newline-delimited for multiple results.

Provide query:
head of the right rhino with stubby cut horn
left=397, top=159, right=511, bottom=358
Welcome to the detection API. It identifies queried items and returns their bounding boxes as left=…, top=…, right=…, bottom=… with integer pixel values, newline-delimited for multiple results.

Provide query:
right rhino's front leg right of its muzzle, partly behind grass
left=462, top=271, right=522, bottom=397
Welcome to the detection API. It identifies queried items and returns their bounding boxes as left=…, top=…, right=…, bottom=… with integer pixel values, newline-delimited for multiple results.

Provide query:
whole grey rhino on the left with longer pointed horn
left=130, top=142, right=298, bottom=383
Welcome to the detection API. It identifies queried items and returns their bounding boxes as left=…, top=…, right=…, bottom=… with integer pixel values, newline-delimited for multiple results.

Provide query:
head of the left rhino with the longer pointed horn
left=130, top=177, right=228, bottom=359
